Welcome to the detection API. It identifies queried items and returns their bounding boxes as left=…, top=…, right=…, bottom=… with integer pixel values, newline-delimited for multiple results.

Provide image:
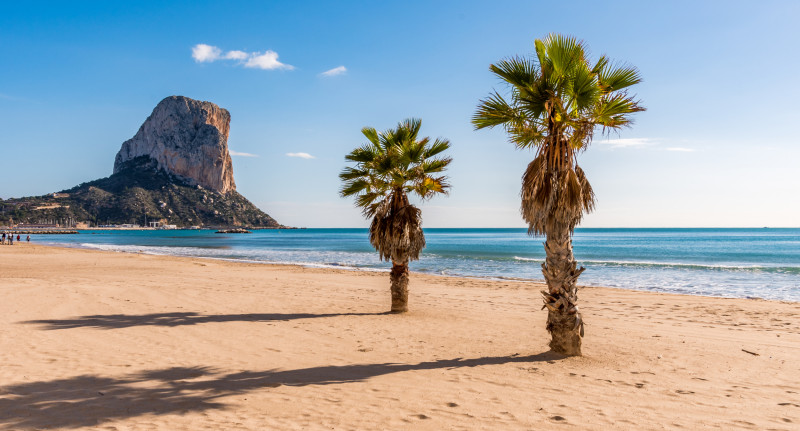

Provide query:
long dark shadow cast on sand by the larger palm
left=0, top=352, right=563, bottom=430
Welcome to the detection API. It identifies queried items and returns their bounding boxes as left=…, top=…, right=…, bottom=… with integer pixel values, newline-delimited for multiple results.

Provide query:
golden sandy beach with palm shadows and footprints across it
left=0, top=244, right=800, bottom=430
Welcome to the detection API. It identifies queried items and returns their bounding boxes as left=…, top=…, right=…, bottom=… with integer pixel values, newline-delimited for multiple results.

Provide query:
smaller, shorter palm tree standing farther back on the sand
left=339, top=119, right=452, bottom=313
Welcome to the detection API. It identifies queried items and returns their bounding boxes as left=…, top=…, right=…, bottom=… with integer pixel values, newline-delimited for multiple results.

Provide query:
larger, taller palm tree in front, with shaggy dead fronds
left=472, top=34, right=644, bottom=355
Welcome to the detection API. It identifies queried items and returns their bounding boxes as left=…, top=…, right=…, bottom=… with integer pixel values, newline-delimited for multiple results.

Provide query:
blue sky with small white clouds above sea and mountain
left=0, top=1, right=800, bottom=227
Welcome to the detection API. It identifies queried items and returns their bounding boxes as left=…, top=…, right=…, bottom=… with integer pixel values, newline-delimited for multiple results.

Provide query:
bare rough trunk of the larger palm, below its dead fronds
left=542, top=226, right=585, bottom=356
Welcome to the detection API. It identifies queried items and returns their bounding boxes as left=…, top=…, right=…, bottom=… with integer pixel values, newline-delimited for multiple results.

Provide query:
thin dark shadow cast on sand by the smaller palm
left=19, top=312, right=389, bottom=331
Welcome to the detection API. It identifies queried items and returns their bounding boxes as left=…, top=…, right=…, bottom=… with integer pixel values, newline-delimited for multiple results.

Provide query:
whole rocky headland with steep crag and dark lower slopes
left=0, top=96, right=285, bottom=228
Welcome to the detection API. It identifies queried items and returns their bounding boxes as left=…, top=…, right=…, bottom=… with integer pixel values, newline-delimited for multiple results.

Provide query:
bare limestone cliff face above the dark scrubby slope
left=114, top=96, right=236, bottom=194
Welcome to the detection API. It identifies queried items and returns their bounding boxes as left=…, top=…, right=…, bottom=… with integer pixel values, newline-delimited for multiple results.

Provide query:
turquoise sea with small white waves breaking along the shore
left=33, top=228, right=800, bottom=301
